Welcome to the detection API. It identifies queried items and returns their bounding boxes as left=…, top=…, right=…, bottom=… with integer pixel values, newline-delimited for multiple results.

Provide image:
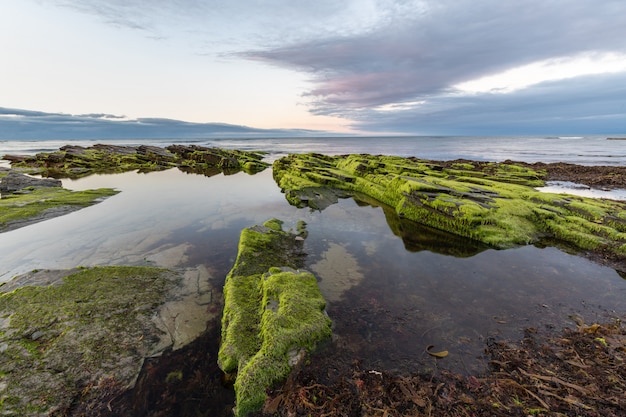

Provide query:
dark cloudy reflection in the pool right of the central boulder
left=307, top=200, right=626, bottom=373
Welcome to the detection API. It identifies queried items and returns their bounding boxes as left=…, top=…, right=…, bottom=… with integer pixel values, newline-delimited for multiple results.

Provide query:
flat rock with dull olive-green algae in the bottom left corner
left=0, top=267, right=175, bottom=415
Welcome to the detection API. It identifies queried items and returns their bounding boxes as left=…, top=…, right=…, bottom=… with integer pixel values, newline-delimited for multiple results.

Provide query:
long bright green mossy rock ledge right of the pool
left=273, top=154, right=626, bottom=258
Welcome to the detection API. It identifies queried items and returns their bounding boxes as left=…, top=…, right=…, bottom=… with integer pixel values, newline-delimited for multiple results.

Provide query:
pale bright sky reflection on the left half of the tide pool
left=0, top=169, right=296, bottom=281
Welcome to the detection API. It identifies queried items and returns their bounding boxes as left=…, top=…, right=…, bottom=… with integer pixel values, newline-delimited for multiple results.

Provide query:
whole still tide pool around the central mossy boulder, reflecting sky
left=0, top=169, right=626, bottom=373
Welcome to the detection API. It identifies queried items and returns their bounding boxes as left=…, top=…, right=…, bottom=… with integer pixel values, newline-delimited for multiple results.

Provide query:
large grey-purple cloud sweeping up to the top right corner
left=239, top=0, right=626, bottom=132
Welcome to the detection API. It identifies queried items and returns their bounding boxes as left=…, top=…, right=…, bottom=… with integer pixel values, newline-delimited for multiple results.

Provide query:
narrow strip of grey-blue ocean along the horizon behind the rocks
left=0, top=135, right=626, bottom=165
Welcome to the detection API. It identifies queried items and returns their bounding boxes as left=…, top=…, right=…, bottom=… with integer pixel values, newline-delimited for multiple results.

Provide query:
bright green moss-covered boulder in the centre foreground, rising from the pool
left=218, top=219, right=331, bottom=416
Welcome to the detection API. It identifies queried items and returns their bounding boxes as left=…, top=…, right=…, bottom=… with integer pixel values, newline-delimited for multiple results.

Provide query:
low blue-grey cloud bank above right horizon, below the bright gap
left=349, top=73, right=626, bottom=135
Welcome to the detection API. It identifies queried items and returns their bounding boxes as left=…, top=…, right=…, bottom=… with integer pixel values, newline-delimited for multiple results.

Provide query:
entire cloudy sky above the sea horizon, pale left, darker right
left=0, top=0, right=626, bottom=139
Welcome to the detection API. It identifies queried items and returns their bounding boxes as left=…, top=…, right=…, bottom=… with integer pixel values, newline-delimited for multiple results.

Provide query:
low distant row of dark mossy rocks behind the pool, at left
left=4, top=144, right=269, bottom=178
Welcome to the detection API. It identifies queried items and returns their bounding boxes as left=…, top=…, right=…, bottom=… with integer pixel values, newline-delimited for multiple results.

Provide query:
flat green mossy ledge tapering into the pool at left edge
left=0, top=187, right=118, bottom=231
